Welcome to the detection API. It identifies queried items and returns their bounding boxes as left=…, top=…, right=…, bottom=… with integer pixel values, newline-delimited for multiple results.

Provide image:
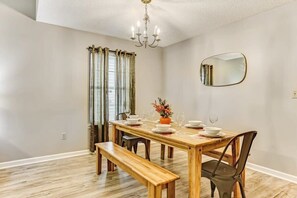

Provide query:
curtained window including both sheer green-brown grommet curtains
left=88, top=46, right=135, bottom=152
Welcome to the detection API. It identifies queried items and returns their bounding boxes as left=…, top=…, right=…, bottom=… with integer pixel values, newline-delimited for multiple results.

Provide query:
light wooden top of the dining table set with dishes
left=110, top=120, right=237, bottom=150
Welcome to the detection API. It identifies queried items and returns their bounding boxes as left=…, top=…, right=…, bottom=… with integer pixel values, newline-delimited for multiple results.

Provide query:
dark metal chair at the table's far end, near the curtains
left=117, top=113, right=150, bottom=161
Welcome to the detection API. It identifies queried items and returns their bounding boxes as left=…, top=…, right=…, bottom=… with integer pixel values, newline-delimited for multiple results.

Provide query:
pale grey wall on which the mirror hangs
left=163, top=2, right=297, bottom=176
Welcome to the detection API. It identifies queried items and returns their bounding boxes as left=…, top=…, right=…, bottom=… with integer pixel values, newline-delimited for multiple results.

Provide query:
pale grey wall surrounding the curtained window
left=0, top=3, right=162, bottom=162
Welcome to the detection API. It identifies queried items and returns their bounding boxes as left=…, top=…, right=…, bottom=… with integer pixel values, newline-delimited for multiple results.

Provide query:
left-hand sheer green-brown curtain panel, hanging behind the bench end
left=89, top=46, right=109, bottom=152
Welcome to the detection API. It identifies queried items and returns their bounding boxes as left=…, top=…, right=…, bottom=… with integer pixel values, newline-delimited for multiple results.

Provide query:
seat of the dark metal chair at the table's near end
left=202, top=160, right=236, bottom=177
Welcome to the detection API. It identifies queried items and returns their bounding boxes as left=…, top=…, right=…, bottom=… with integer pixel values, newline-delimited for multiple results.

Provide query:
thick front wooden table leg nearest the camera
left=188, top=147, right=202, bottom=198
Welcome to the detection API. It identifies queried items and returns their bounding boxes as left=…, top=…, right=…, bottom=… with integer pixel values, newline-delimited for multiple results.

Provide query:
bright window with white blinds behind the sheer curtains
left=90, top=52, right=130, bottom=123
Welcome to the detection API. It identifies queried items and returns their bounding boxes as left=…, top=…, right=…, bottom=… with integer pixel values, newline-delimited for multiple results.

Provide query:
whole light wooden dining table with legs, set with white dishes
left=110, top=120, right=239, bottom=198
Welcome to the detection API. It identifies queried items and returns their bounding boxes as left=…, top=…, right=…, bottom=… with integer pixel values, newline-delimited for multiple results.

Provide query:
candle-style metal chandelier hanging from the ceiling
left=131, top=0, right=161, bottom=48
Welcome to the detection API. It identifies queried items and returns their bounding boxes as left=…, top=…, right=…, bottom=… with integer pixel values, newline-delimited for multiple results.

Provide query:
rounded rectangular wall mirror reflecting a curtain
left=200, top=52, right=247, bottom=87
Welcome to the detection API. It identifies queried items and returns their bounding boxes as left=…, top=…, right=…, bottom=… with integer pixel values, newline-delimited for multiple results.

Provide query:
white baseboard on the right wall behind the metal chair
left=246, top=162, right=297, bottom=184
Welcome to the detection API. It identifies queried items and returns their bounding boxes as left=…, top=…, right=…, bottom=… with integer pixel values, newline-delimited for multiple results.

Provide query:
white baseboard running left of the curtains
left=0, top=150, right=89, bottom=170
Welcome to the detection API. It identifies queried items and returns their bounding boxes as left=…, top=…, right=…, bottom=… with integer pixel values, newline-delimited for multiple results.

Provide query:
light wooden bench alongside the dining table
left=96, top=142, right=179, bottom=198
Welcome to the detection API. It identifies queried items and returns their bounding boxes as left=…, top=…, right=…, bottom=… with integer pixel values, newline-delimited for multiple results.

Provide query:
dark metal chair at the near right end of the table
left=202, top=131, right=257, bottom=198
